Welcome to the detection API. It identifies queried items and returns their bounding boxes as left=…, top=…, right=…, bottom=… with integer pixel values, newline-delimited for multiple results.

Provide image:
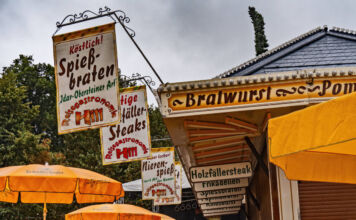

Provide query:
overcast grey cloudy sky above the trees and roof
left=0, top=0, right=356, bottom=103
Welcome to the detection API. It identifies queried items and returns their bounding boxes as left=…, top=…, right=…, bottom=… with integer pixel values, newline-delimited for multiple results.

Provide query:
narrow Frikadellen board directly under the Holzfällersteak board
left=194, top=178, right=248, bottom=192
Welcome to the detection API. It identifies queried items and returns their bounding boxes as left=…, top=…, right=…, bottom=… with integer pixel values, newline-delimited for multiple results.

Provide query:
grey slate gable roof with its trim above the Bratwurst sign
left=216, top=26, right=356, bottom=78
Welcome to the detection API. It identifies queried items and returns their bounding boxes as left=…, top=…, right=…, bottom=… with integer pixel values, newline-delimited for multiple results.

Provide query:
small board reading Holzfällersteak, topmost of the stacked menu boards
left=190, top=162, right=252, bottom=183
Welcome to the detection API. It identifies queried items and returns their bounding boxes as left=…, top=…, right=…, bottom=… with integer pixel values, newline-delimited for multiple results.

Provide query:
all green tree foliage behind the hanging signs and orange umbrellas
left=0, top=55, right=171, bottom=219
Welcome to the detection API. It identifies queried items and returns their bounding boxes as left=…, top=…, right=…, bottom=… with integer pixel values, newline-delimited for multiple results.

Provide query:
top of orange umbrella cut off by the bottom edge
left=65, top=204, right=164, bottom=220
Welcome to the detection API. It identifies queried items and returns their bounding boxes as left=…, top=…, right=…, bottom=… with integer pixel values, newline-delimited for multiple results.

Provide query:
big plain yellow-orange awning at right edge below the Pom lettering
left=268, top=92, right=356, bottom=184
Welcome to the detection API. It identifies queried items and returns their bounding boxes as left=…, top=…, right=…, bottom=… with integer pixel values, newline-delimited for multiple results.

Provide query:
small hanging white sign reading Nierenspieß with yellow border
left=141, top=147, right=175, bottom=199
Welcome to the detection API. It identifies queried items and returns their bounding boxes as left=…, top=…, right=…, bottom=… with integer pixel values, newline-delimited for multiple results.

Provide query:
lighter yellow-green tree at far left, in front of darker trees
left=0, top=60, right=58, bottom=219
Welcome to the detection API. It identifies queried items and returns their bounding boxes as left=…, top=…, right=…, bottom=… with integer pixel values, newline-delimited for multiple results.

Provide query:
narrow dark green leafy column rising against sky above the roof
left=248, top=7, right=268, bottom=56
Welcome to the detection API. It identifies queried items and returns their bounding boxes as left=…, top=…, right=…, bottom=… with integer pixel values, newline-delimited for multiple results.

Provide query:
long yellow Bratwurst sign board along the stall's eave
left=159, top=73, right=356, bottom=118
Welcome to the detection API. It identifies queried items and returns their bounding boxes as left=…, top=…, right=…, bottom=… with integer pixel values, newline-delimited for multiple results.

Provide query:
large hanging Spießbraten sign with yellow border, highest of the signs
left=53, top=24, right=120, bottom=134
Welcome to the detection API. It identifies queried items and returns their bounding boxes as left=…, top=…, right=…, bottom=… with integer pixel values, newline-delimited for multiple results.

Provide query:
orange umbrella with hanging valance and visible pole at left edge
left=0, top=164, right=124, bottom=219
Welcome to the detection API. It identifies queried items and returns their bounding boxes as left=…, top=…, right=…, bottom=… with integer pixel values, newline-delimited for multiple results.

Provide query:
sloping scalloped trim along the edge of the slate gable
left=214, top=25, right=356, bottom=78
